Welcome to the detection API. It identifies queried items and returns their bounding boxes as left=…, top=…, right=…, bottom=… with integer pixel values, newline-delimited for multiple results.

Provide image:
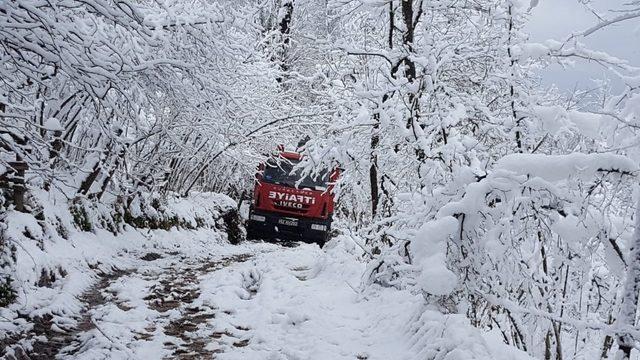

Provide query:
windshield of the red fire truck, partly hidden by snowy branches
left=262, top=160, right=329, bottom=190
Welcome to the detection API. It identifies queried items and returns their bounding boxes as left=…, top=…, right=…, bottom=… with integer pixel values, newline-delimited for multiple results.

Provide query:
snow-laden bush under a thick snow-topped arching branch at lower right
left=358, top=148, right=638, bottom=359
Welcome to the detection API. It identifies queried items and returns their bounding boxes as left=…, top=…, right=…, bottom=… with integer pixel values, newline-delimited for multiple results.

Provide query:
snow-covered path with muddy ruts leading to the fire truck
left=2, top=226, right=527, bottom=360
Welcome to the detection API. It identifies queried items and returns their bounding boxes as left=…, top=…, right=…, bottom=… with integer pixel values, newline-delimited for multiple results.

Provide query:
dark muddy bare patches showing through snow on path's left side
left=0, top=253, right=252, bottom=360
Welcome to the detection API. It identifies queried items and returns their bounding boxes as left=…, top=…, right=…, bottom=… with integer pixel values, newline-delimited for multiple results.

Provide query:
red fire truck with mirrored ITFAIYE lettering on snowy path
left=247, top=150, right=339, bottom=247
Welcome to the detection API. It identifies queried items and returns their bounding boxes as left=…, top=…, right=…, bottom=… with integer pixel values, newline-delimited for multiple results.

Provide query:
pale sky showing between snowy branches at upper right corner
left=526, top=0, right=640, bottom=90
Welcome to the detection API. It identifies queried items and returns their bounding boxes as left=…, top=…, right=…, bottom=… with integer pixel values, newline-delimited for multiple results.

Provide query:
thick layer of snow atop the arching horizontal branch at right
left=495, top=153, right=638, bottom=181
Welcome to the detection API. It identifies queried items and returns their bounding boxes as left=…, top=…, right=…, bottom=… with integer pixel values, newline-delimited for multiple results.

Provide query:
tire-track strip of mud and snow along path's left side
left=0, top=252, right=253, bottom=360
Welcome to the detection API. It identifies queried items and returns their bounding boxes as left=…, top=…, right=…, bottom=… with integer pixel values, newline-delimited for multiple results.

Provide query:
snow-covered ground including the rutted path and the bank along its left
left=0, top=190, right=528, bottom=360
